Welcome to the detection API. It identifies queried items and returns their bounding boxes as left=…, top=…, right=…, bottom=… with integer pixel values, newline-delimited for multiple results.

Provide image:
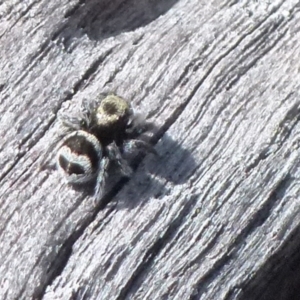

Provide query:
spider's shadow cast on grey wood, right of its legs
left=111, top=134, right=197, bottom=209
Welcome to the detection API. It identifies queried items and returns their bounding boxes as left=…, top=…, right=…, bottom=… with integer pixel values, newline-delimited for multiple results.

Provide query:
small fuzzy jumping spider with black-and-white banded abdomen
left=56, top=94, right=156, bottom=199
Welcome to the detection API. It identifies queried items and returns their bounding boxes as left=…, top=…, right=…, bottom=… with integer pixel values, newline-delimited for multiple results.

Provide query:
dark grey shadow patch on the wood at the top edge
left=53, top=0, right=178, bottom=49
